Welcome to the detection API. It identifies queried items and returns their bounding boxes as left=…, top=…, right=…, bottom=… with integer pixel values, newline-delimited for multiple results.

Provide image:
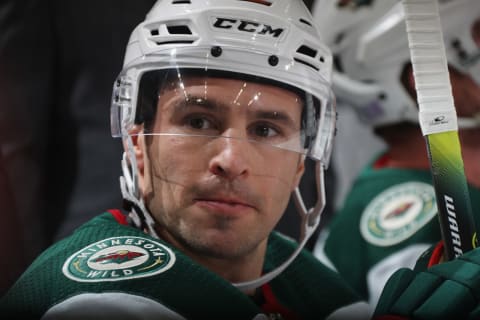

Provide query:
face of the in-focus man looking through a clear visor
left=139, top=77, right=304, bottom=258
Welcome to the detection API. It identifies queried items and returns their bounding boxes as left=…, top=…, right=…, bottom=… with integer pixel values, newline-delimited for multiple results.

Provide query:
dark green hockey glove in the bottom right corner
left=374, top=248, right=480, bottom=320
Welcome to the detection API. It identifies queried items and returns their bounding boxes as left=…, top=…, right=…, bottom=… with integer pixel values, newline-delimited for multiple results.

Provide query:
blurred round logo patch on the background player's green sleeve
left=360, top=182, right=437, bottom=246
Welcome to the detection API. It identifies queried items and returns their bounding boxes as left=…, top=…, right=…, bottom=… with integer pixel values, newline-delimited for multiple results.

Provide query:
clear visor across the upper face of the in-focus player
left=111, top=49, right=335, bottom=165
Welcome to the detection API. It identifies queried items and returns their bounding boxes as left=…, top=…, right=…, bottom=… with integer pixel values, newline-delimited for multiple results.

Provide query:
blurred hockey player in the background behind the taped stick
left=313, top=0, right=480, bottom=305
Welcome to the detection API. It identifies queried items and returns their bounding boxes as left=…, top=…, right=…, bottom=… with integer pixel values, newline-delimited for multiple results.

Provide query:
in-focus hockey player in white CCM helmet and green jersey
left=0, top=0, right=368, bottom=319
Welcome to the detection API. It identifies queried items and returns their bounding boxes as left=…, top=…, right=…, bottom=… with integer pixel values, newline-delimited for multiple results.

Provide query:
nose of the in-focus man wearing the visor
left=209, top=136, right=253, bottom=180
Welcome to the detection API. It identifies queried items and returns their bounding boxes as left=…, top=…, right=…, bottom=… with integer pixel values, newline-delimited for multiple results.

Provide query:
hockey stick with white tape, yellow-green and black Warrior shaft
left=402, top=0, right=477, bottom=260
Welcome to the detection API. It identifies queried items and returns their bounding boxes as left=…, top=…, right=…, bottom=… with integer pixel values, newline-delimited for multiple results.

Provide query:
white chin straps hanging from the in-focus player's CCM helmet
left=120, top=136, right=325, bottom=292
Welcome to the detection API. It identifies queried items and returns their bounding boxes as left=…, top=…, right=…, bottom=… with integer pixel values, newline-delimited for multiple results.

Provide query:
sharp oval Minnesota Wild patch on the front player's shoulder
left=62, top=236, right=175, bottom=282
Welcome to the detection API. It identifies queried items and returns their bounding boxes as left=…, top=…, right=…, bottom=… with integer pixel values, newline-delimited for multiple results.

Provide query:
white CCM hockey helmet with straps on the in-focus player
left=111, top=0, right=336, bottom=290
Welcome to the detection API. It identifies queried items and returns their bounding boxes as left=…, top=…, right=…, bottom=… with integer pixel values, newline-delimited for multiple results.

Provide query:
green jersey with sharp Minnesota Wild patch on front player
left=0, top=210, right=369, bottom=319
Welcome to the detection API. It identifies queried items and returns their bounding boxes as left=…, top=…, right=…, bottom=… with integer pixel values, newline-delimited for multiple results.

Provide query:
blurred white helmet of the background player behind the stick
left=312, top=0, right=480, bottom=128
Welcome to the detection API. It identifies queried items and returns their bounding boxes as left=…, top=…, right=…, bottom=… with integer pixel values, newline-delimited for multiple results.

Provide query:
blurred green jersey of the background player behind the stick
left=324, top=157, right=480, bottom=305
